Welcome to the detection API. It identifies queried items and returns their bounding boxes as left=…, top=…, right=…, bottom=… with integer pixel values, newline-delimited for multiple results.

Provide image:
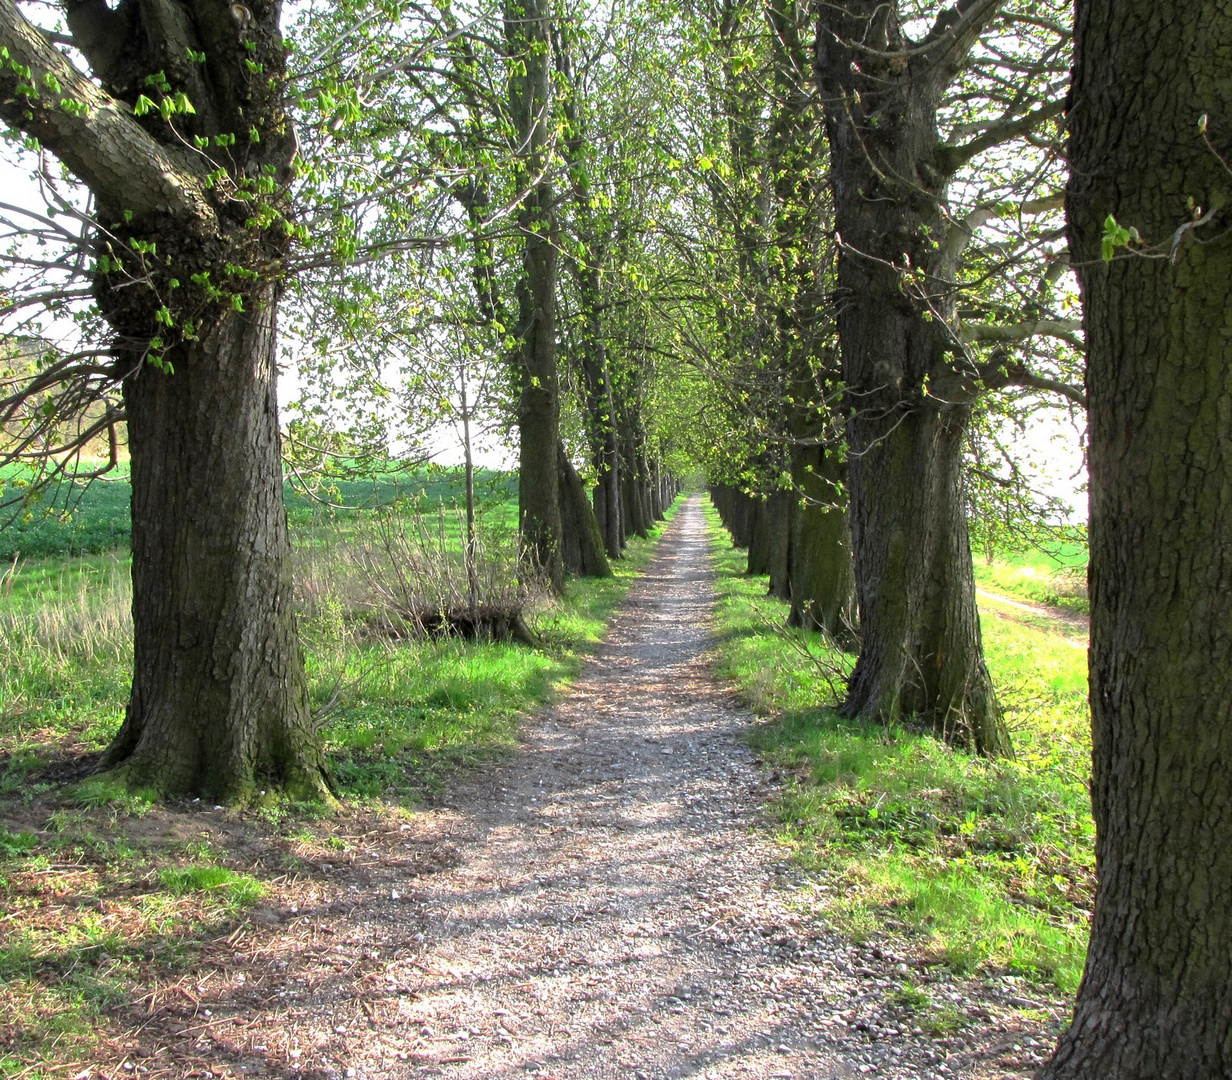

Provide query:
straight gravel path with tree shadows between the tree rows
left=247, top=499, right=1042, bottom=1080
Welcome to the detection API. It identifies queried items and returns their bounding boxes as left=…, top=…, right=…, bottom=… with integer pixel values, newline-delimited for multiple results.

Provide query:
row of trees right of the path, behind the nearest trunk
left=712, top=2, right=1084, bottom=755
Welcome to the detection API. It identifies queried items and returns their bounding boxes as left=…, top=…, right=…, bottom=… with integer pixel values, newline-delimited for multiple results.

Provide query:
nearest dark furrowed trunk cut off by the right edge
left=1040, top=0, right=1232, bottom=1080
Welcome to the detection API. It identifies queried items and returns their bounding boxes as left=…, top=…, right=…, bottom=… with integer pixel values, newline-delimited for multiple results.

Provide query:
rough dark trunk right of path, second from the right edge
left=818, top=0, right=1010, bottom=755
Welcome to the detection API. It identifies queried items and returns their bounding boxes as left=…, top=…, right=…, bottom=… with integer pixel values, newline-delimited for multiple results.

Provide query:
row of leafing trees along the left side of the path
left=0, top=0, right=694, bottom=800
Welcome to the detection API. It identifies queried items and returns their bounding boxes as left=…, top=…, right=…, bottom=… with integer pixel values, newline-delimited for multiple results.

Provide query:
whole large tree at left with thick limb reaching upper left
left=0, top=0, right=329, bottom=799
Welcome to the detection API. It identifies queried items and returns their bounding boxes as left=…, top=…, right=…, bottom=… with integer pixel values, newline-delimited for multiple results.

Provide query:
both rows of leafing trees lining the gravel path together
left=0, top=0, right=1232, bottom=1078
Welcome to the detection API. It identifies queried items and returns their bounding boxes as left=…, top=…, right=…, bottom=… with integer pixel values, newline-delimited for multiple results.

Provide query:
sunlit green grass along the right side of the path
left=707, top=497, right=1094, bottom=994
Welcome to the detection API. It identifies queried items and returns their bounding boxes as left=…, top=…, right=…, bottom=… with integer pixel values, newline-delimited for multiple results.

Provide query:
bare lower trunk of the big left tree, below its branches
left=102, top=295, right=328, bottom=802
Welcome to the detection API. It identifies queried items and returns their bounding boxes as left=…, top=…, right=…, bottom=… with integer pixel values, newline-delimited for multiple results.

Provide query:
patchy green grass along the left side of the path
left=0, top=475, right=684, bottom=1076
